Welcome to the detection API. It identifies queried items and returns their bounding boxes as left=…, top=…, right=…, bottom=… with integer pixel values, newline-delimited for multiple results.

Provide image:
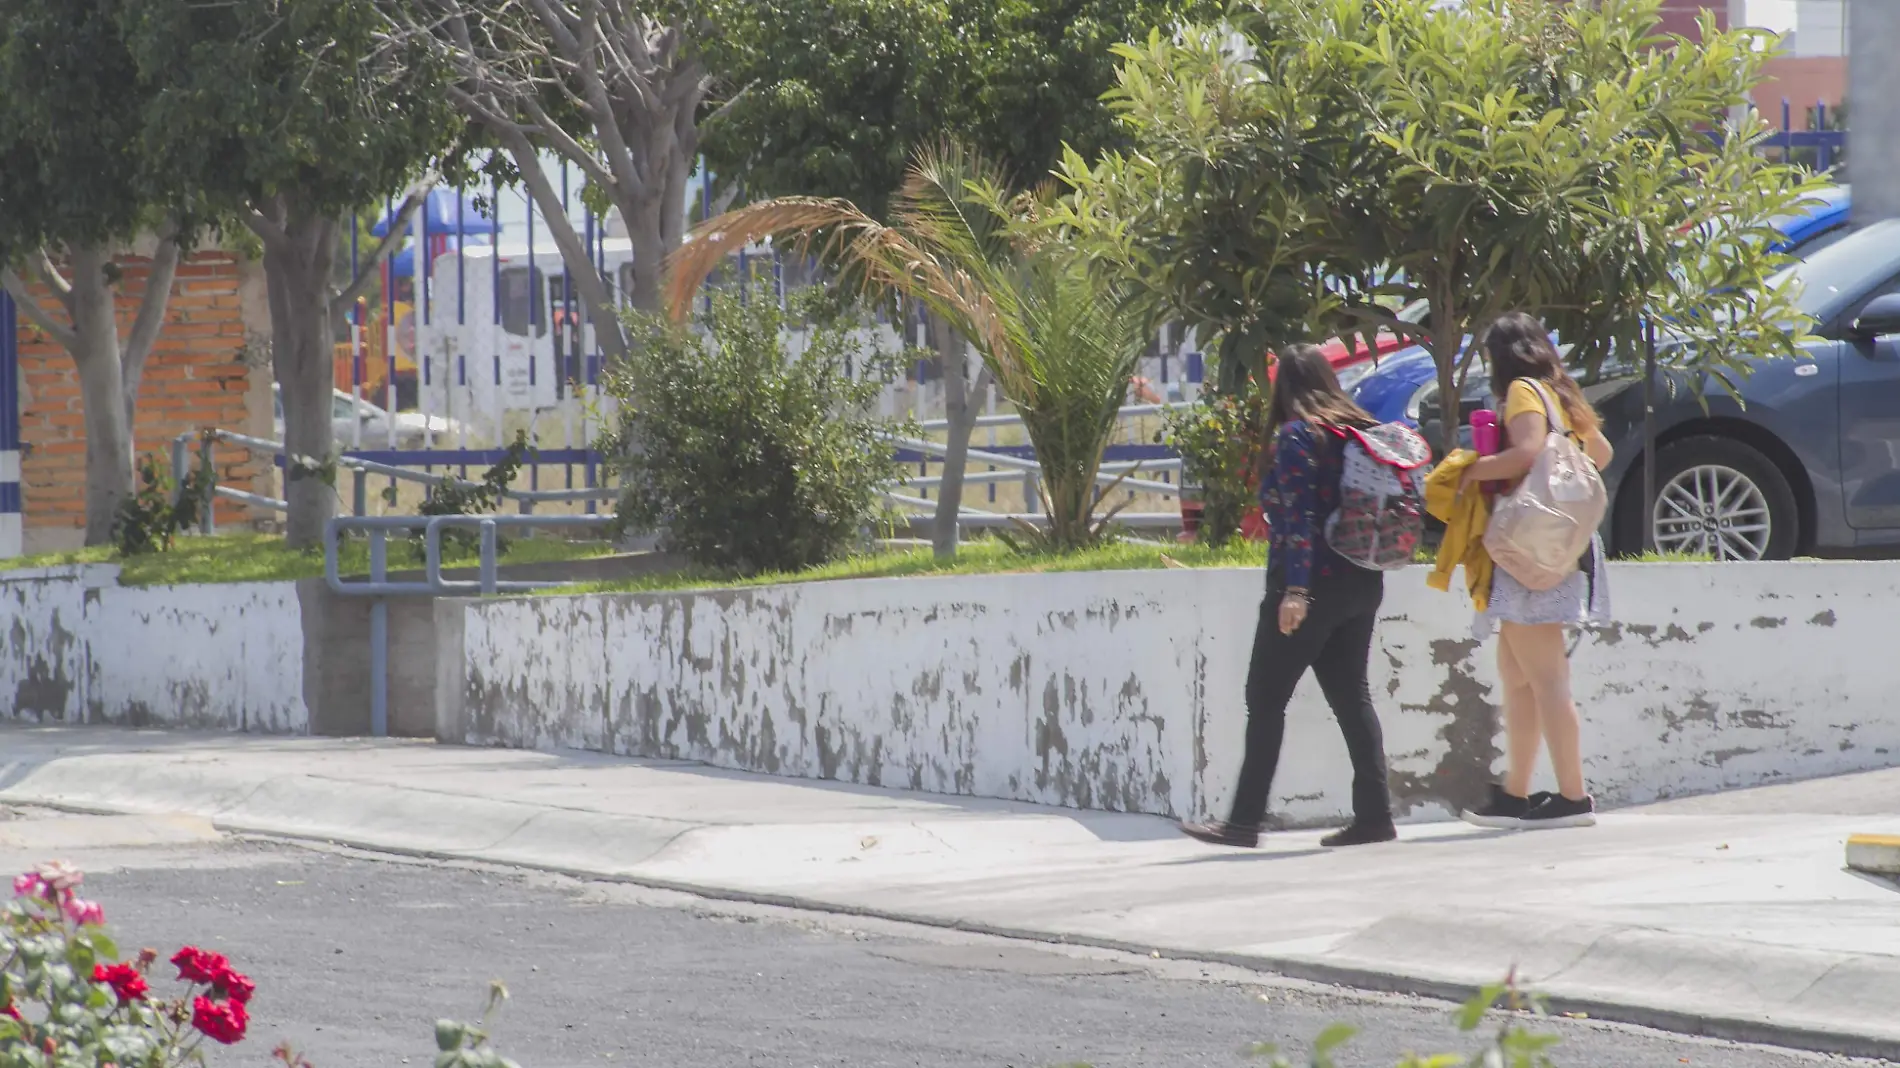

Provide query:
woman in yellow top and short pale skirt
left=1461, top=312, right=1611, bottom=829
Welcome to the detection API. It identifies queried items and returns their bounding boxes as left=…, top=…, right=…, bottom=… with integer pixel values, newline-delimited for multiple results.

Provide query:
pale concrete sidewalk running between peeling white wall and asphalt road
left=0, top=728, right=1900, bottom=1058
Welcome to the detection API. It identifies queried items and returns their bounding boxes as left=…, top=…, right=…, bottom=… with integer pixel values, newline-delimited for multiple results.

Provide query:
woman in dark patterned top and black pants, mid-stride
left=1182, top=344, right=1398, bottom=848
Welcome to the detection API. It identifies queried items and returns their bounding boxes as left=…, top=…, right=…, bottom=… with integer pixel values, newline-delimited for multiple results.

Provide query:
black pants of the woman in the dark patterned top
left=1229, top=564, right=1393, bottom=827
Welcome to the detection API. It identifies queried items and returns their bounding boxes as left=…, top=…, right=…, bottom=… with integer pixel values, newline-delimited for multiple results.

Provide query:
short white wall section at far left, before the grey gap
left=0, top=566, right=310, bottom=734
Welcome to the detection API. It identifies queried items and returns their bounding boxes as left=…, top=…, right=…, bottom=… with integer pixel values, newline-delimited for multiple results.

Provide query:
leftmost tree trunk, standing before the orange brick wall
left=72, top=245, right=133, bottom=545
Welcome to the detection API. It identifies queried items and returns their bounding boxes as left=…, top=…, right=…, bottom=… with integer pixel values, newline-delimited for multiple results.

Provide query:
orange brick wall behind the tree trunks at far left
left=19, top=251, right=270, bottom=551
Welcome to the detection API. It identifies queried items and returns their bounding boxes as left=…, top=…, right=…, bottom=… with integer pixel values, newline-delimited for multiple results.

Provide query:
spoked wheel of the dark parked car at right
left=1617, top=437, right=1801, bottom=561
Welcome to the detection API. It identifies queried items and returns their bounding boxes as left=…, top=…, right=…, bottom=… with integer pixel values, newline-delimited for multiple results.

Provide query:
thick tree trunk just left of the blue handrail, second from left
left=264, top=207, right=336, bottom=549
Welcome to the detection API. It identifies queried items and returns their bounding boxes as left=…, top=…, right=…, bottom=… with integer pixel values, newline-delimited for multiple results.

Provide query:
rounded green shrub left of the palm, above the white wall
left=600, top=291, right=897, bottom=574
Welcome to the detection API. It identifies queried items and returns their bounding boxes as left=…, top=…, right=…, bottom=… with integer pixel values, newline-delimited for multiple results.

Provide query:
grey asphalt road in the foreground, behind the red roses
left=11, top=842, right=1869, bottom=1068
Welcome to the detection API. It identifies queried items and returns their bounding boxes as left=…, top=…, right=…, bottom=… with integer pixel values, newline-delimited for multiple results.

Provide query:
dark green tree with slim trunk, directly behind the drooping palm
left=701, top=0, right=1214, bottom=553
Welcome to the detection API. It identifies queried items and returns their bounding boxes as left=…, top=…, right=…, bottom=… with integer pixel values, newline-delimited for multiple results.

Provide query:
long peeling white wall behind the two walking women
left=456, top=563, right=1900, bottom=823
